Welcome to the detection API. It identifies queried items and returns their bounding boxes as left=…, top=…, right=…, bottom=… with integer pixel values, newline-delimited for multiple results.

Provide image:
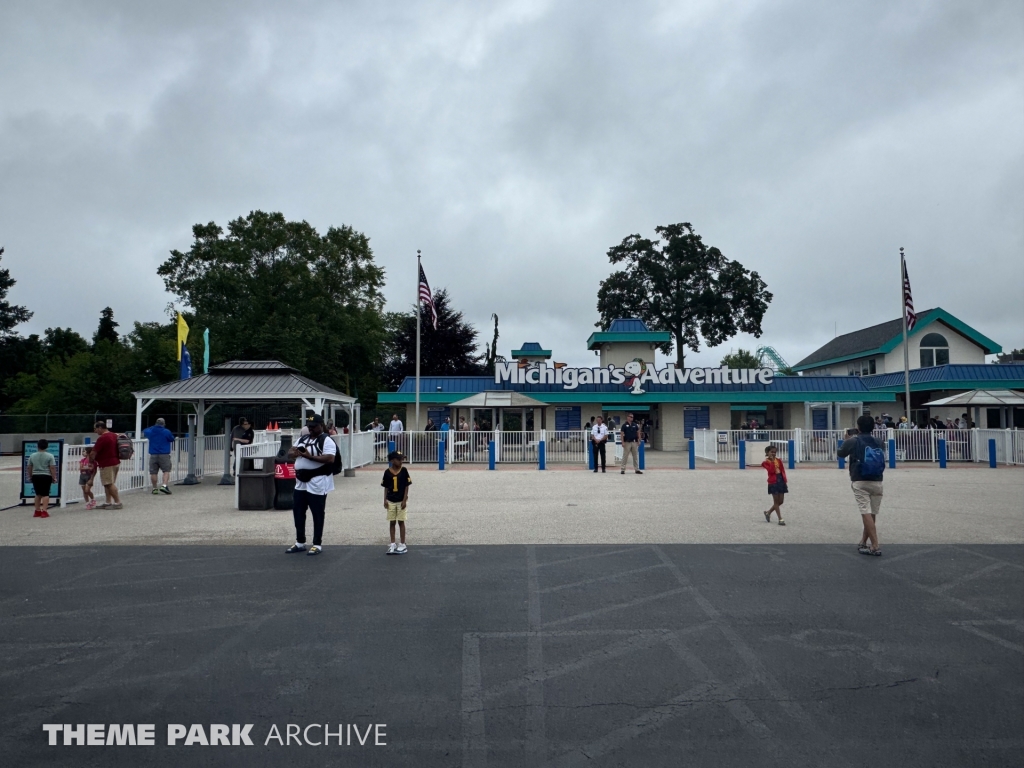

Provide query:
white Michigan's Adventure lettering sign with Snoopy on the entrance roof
left=495, top=359, right=775, bottom=394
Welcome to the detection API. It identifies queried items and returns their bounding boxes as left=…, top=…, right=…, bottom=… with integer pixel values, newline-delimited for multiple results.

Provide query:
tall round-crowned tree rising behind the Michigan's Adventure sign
left=597, top=222, right=772, bottom=368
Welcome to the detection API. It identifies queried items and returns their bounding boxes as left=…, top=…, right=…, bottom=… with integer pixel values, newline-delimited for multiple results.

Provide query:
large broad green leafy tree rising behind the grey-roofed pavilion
left=158, top=211, right=384, bottom=399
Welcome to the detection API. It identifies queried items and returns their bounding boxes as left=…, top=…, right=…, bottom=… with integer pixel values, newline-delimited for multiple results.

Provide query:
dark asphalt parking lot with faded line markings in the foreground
left=0, top=544, right=1024, bottom=768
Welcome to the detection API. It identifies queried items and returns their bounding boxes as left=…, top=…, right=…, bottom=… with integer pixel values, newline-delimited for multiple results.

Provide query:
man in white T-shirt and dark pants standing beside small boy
left=286, top=414, right=338, bottom=555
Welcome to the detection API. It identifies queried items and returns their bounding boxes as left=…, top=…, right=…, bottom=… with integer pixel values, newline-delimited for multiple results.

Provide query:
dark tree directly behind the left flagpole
left=382, top=289, right=486, bottom=388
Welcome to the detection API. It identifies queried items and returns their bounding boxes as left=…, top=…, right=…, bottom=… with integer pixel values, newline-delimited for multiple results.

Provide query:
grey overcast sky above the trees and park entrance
left=0, top=0, right=1024, bottom=372
